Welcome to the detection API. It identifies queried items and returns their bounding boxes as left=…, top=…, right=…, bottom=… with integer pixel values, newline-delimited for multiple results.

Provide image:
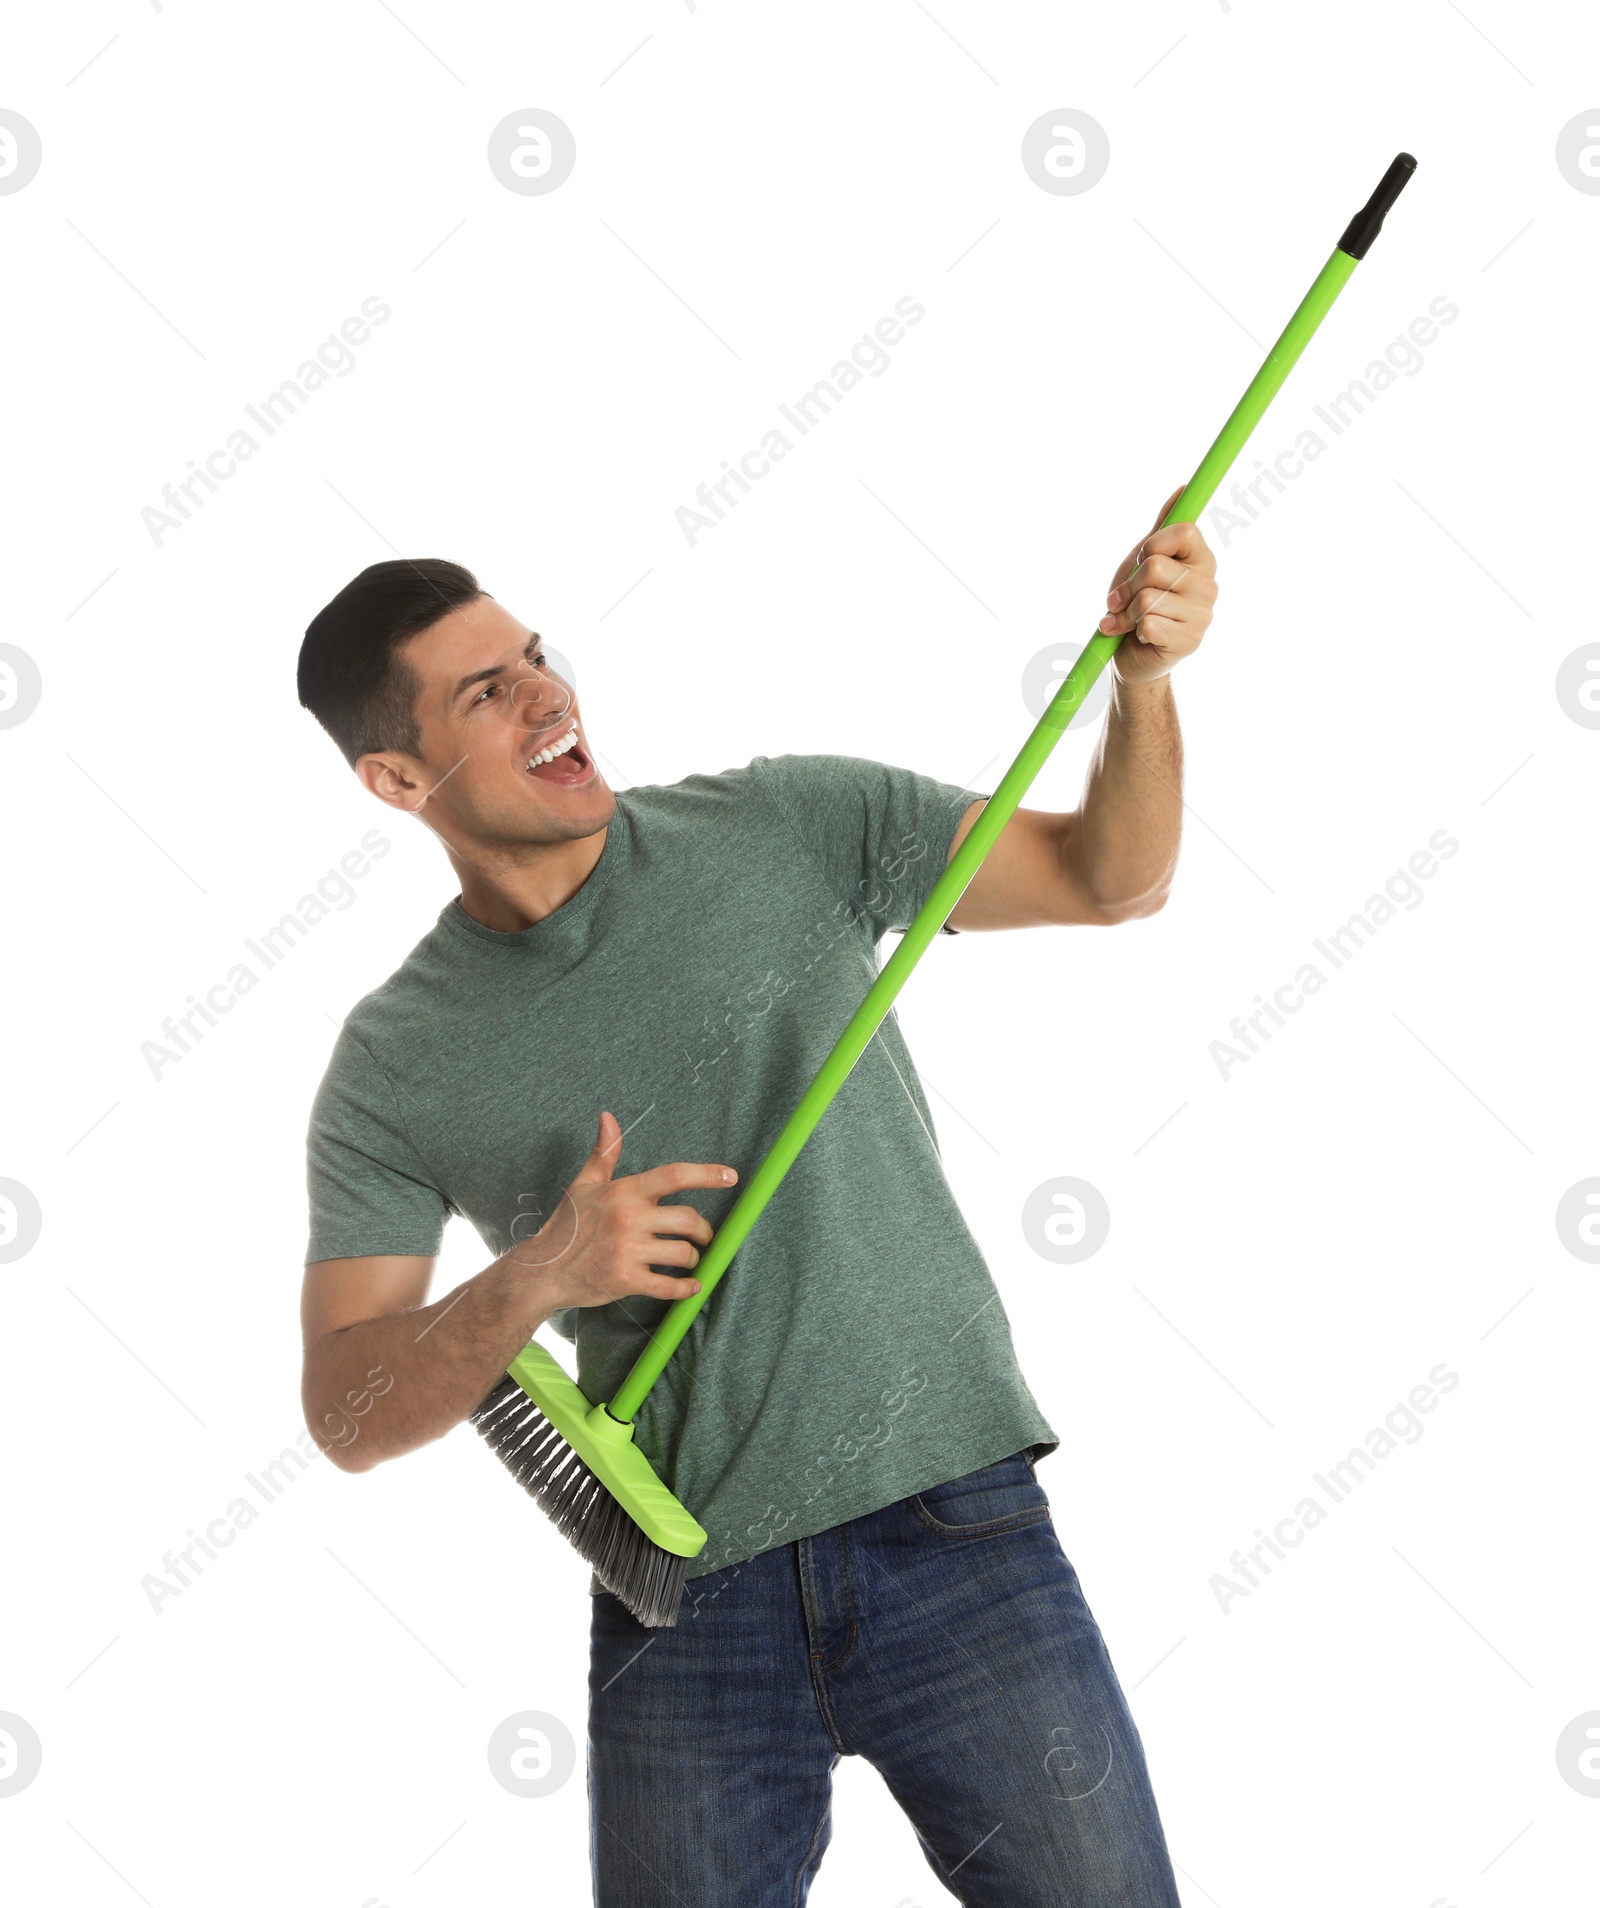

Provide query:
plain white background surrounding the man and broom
left=0, top=0, right=1600, bottom=1908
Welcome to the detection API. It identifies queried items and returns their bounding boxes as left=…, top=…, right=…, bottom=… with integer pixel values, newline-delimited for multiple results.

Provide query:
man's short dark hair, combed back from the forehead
left=296, top=557, right=488, bottom=767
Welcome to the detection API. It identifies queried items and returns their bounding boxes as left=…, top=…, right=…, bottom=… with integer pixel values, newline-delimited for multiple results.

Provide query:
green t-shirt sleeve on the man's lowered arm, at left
left=305, top=1028, right=452, bottom=1265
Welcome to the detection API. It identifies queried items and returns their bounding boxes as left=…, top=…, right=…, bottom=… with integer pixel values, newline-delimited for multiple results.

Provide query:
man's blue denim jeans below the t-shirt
left=589, top=1452, right=1179, bottom=1908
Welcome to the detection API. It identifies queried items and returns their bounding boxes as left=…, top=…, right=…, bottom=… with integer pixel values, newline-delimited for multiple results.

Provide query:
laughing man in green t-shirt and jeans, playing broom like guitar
left=299, top=492, right=1217, bottom=1908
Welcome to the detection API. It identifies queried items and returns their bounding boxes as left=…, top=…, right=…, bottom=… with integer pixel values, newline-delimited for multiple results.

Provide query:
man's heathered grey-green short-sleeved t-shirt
left=307, top=756, right=1058, bottom=1576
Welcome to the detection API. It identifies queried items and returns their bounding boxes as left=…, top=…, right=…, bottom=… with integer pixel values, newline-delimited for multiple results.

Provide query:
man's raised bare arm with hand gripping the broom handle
left=950, top=490, right=1217, bottom=929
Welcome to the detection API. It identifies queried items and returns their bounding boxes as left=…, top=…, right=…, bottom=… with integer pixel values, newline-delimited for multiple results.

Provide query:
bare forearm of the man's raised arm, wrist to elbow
left=1062, top=675, right=1182, bottom=922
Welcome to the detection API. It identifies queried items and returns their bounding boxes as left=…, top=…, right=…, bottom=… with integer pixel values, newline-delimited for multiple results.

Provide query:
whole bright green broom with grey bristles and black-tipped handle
left=471, top=153, right=1417, bottom=1628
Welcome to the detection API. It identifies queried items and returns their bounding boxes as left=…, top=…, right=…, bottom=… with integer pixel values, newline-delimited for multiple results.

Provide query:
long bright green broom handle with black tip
left=608, top=153, right=1417, bottom=1423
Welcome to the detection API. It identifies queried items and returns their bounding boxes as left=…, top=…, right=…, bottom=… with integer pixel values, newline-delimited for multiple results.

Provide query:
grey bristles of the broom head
left=471, top=1372, right=688, bottom=1629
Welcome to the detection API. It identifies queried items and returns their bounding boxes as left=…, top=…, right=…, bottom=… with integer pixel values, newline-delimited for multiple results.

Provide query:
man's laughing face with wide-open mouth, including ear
left=362, top=597, right=616, bottom=845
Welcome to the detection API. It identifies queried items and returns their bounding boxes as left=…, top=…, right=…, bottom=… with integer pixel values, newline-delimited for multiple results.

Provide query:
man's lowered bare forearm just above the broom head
left=301, top=1259, right=557, bottom=1471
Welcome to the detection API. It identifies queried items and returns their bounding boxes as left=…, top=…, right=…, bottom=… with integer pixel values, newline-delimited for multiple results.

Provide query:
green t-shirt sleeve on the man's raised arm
left=753, top=756, right=982, bottom=939
